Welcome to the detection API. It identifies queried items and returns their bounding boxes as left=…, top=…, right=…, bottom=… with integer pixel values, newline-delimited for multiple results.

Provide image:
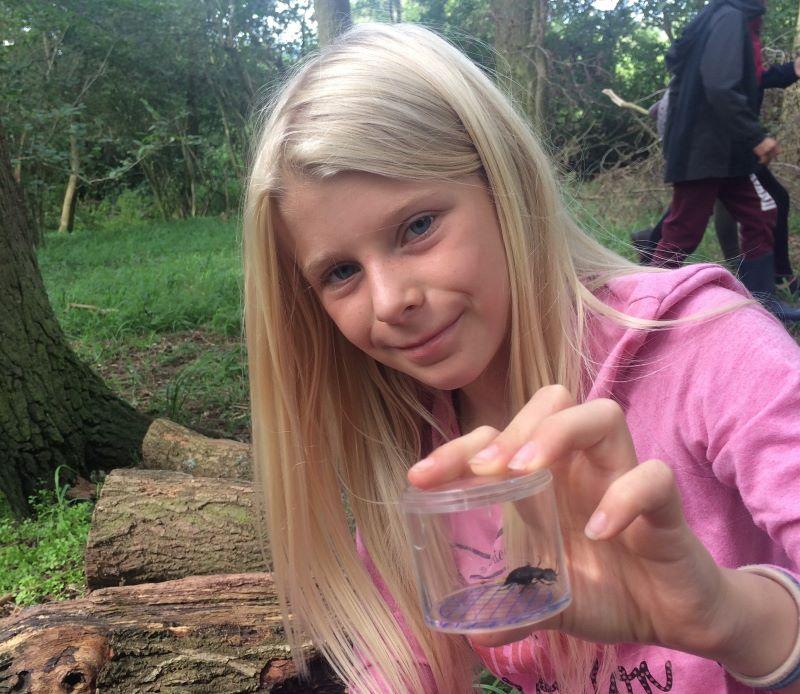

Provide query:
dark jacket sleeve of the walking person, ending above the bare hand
left=700, top=11, right=766, bottom=147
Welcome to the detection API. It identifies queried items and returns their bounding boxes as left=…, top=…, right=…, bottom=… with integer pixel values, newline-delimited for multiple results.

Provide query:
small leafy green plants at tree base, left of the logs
left=0, top=466, right=93, bottom=605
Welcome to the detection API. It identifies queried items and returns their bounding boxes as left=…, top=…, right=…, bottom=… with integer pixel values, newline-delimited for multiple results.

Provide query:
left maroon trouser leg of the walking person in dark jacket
left=653, top=178, right=724, bottom=267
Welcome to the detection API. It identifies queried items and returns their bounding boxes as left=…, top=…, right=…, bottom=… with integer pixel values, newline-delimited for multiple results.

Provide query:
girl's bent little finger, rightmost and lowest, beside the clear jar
left=585, top=460, right=684, bottom=540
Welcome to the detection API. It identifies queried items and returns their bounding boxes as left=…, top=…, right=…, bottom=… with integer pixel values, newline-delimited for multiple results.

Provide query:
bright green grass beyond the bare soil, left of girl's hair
left=39, top=218, right=241, bottom=340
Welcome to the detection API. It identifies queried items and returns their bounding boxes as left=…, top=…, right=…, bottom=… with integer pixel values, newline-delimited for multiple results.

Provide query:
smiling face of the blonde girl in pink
left=277, top=173, right=510, bottom=390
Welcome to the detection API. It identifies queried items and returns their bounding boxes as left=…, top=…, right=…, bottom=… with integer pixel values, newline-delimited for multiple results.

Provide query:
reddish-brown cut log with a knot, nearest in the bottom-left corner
left=0, top=573, right=344, bottom=694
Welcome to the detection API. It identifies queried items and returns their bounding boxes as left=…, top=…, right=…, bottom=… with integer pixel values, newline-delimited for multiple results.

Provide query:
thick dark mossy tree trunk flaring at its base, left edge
left=0, top=122, right=150, bottom=515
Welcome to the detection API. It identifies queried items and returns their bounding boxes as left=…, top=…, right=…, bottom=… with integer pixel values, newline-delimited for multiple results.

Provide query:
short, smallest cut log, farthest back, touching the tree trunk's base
left=142, top=419, right=253, bottom=480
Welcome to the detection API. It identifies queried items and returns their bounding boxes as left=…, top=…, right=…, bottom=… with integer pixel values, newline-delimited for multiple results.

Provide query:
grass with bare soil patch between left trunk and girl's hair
left=38, top=218, right=249, bottom=438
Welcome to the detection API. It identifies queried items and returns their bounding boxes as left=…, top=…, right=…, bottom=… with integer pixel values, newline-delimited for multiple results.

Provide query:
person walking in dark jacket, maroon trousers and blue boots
left=653, top=0, right=800, bottom=320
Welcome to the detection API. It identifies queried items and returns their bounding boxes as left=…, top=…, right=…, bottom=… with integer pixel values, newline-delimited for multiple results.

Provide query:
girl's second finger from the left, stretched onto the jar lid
left=469, top=385, right=575, bottom=475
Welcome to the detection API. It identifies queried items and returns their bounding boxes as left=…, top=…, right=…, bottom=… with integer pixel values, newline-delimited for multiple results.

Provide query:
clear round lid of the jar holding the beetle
left=400, top=468, right=553, bottom=513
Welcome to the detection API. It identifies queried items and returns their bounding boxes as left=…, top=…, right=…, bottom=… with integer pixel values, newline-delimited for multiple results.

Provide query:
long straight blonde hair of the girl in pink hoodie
left=244, top=24, right=676, bottom=692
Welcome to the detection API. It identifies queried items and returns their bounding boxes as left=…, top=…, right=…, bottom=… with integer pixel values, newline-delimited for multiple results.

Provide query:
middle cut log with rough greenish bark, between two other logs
left=86, top=468, right=264, bottom=589
